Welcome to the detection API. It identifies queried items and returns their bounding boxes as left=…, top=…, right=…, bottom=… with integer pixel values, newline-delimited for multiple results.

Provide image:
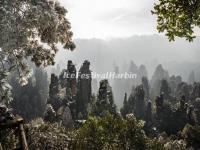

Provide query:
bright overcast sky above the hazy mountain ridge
left=59, top=0, right=157, bottom=39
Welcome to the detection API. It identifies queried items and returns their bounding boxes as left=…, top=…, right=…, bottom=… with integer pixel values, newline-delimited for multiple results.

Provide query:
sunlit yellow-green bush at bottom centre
left=71, top=115, right=162, bottom=150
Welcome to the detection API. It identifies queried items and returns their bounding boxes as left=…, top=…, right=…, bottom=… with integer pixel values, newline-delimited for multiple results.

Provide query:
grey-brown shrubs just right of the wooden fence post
left=26, top=120, right=70, bottom=150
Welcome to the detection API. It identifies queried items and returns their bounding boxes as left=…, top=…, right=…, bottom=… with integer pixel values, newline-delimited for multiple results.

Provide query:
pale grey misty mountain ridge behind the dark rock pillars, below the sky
left=50, top=35, right=200, bottom=104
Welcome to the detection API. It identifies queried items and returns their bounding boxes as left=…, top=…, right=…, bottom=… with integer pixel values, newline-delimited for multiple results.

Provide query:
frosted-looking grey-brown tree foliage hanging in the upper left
left=0, top=0, right=75, bottom=101
